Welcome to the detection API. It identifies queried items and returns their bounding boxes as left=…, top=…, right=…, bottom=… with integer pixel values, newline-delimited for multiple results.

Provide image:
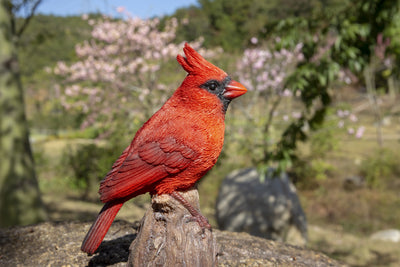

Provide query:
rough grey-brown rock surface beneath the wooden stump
left=0, top=221, right=341, bottom=266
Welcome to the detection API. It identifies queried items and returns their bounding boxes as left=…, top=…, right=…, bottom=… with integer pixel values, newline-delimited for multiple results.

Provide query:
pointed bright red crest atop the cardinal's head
left=176, top=43, right=227, bottom=77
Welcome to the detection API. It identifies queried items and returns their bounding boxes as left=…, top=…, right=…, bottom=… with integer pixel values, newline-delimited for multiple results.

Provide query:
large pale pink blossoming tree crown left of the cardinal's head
left=53, top=16, right=222, bottom=134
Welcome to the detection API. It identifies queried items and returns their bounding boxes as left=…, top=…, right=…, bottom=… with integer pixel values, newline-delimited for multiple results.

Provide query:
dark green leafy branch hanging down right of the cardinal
left=260, top=0, right=400, bottom=174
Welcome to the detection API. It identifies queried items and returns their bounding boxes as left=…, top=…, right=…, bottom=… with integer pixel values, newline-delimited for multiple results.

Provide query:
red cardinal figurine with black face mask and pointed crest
left=81, top=43, right=247, bottom=255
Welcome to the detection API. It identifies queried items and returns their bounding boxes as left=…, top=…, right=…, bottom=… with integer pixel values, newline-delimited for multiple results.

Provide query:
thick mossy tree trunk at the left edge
left=0, top=0, right=45, bottom=227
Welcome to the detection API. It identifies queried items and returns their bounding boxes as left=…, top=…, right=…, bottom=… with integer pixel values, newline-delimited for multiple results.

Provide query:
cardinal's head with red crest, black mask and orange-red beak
left=177, top=43, right=247, bottom=112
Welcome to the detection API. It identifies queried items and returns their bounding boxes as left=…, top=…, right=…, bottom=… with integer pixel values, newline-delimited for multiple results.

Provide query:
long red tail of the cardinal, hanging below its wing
left=81, top=202, right=124, bottom=255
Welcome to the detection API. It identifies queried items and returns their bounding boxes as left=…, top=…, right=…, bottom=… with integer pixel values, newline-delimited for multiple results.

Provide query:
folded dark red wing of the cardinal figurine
left=99, top=137, right=196, bottom=202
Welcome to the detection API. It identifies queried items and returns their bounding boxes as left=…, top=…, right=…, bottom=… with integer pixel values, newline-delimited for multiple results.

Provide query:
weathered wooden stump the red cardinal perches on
left=127, top=189, right=217, bottom=266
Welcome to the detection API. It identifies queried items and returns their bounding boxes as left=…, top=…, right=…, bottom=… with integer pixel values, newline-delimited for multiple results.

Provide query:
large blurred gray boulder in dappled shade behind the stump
left=216, top=168, right=307, bottom=243
